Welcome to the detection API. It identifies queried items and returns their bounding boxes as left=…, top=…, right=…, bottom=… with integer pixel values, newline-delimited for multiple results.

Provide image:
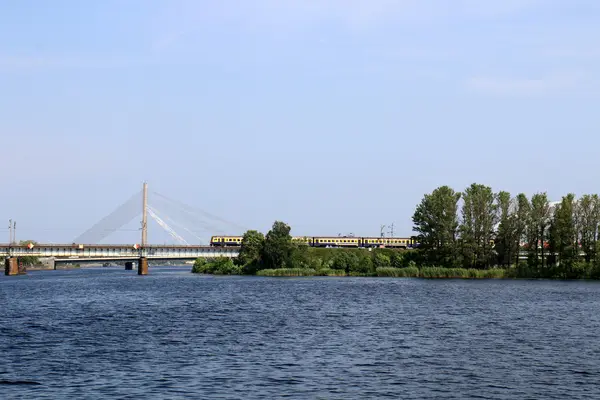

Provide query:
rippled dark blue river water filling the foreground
left=0, top=268, right=600, bottom=399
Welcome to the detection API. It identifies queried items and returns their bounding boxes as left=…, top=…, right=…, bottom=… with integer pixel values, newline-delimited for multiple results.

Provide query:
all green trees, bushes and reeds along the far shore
left=192, top=183, right=600, bottom=280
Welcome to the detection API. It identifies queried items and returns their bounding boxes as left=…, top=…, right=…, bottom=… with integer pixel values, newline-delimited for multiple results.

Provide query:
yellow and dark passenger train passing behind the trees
left=210, top=236, right=419, bottom=249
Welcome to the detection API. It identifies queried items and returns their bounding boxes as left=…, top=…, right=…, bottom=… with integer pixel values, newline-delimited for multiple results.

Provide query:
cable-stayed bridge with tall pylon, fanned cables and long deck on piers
left=0, top=183, right=241, bottom=275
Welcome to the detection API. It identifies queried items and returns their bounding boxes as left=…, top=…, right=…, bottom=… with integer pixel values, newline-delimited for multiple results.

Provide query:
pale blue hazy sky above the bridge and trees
left=0, top=0, right=600, bottom=243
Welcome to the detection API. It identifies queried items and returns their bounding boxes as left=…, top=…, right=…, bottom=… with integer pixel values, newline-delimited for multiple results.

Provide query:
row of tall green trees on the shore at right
left=412, top=184, right=600, bottom=278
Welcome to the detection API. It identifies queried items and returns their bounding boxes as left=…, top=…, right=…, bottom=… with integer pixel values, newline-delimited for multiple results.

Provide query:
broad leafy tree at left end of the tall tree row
left=412, top=186, right=461, bottom=266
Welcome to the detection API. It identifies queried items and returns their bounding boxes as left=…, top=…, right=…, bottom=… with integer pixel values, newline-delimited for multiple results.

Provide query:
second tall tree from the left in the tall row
left=460, top=183, right=498, bottom=267
